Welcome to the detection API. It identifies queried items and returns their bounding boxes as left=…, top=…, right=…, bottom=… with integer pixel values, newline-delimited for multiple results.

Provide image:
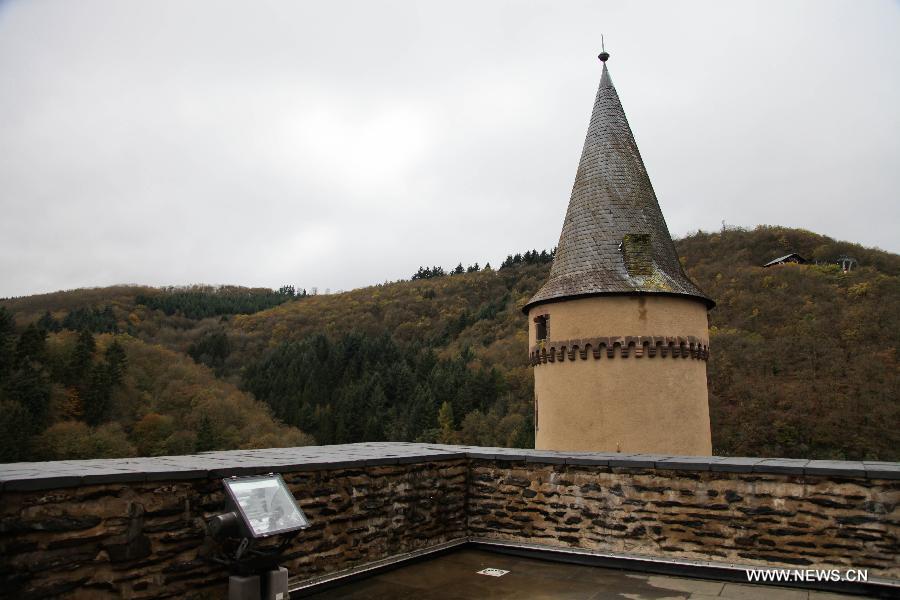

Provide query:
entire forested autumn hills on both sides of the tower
left=0, top=227, right=900, bottom=460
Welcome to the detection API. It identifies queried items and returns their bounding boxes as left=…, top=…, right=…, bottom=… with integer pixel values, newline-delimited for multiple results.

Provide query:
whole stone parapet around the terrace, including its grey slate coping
left=0, top=443, right=900, bottom=598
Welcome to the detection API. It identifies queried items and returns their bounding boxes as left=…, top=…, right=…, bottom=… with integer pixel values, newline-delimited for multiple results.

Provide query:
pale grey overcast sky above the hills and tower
left=0, top=0, right=900, bottom=296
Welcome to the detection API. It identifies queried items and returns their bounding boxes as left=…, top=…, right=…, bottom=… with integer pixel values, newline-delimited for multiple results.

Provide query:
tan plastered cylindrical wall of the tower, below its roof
left=528, top=295, right=712, bottom=456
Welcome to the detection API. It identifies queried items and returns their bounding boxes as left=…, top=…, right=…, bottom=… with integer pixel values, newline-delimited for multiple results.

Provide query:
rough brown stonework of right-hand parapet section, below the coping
left=468, top=459, right=900, bottom=578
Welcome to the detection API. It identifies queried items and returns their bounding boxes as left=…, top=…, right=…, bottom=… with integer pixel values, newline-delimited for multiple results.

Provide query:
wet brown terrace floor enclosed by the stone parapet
left=294, top=548, right=859, bottom=600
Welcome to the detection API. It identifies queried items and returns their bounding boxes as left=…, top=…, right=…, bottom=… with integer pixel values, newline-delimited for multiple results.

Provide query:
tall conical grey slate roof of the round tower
left=524, top=54, right=715, bottom=311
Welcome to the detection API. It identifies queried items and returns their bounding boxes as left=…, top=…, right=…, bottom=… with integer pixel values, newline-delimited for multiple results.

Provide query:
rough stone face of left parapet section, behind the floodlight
left=0, top=460, right=466, bottom=599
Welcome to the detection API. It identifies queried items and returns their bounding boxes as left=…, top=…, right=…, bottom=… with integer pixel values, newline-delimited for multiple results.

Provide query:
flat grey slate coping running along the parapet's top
left=0, top=442, right=900, bottom=492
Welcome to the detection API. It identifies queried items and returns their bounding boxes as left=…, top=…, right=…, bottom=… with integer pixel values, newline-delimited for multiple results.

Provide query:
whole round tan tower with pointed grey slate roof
left=523, top=52, right=714, bottom=455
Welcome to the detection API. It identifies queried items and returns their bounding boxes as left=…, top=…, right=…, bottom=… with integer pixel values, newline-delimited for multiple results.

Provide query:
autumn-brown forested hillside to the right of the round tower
left=678, top=227, right=900, bottom=460
